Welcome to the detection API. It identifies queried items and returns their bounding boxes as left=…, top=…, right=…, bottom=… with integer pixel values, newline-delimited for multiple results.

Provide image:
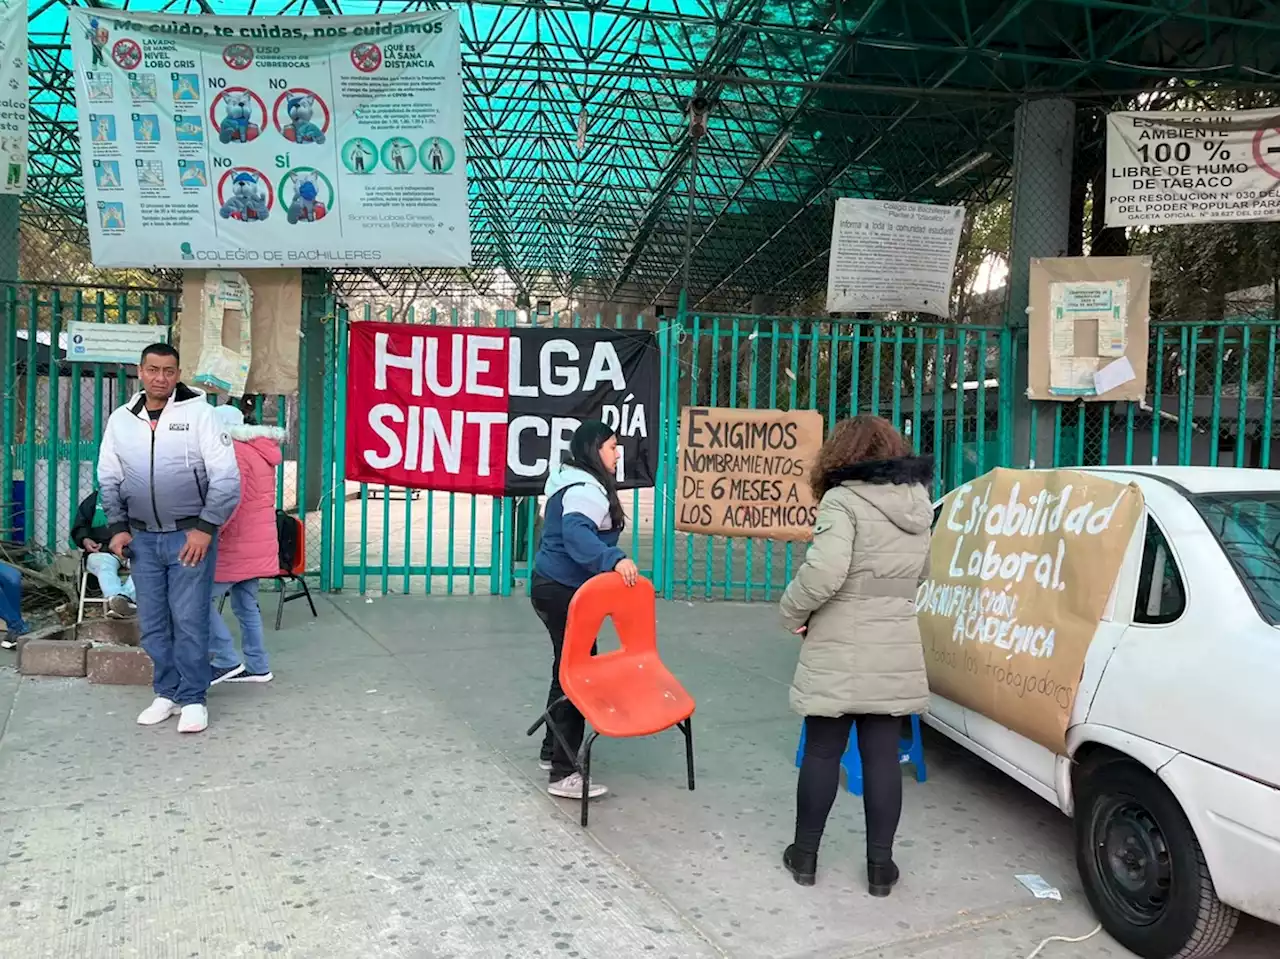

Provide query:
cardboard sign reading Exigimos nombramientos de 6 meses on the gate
left=676, top=407, right=822, bottom=540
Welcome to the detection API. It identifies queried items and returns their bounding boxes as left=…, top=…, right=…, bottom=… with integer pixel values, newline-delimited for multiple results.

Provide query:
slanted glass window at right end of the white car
left=1192, top=493, right=1280, bottom=626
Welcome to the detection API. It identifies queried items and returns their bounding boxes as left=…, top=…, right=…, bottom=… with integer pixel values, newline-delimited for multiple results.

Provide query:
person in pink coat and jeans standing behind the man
left=209, top=405, right=285, bottom=684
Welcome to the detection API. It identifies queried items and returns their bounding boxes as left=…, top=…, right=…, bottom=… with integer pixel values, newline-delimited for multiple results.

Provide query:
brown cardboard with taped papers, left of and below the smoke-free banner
left=1027, top=256, right=1151, bottom=402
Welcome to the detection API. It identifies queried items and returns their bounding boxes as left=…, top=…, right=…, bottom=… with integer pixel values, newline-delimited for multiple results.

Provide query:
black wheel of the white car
left=1075, top=759, right=1240, bottom=959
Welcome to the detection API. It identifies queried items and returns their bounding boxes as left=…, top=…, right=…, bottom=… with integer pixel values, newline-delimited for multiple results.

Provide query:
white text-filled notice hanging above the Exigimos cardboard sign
left=827, top=198, right=964, bottom=316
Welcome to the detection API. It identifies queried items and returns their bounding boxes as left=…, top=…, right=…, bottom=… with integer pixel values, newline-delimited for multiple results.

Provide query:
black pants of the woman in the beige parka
left=796, top=716, right=902, bottom=863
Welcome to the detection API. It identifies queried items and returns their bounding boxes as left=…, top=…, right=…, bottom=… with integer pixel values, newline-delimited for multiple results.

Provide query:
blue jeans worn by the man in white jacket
left=132, top=530, right=218, bottom=705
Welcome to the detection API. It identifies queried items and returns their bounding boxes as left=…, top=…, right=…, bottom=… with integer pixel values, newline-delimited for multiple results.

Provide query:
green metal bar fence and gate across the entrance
left=0, top=284, right=1280, bottom=600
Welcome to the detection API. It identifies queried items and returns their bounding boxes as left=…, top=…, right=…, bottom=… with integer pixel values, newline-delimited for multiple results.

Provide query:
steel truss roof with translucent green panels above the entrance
left=23, top=0, right=1280, bottom=307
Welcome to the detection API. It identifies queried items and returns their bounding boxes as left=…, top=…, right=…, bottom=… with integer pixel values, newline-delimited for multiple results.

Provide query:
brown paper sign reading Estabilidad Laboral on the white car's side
left=916, top=470, right=1143, bottom=754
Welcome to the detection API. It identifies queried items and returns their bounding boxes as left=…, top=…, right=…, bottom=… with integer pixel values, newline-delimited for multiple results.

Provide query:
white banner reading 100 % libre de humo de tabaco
left=1106, top=109, right=1280, bottom=227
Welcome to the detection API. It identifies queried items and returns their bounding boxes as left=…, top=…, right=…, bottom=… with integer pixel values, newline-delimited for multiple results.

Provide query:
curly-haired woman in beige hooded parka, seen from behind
left=782, top=416, right=933, bottom=896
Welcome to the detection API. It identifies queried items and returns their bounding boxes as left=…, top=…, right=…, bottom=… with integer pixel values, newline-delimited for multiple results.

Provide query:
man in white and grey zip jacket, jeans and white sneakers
left=97, top=343, right=239, bottom=732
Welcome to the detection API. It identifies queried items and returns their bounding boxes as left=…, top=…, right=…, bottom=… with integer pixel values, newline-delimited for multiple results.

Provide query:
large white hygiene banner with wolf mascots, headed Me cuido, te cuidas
left=68, top=6, right=471, bottom=269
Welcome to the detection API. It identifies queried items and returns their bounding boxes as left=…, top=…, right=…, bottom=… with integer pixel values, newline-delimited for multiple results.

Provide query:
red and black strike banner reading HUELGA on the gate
left=347, top=323, right=659, bottom=496
